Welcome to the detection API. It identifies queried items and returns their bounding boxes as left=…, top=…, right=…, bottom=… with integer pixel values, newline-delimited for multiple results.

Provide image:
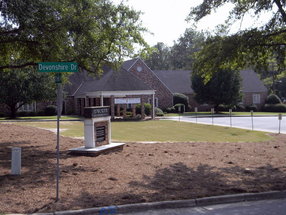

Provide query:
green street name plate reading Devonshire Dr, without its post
left=38, top=62, right=78, bottom=72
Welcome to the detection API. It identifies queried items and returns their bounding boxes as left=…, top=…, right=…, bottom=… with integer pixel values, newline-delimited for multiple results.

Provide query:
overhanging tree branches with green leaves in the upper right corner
left=188, top=0, right=286, bottom=79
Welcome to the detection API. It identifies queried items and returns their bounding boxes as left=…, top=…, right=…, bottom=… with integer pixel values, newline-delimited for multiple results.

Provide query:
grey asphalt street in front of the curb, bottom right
left=122, top=199, right=286, bottom=215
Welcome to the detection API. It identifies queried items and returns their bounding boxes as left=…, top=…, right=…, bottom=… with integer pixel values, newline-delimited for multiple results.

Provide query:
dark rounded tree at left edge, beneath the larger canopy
left=0, top=68, right=55, bottom=118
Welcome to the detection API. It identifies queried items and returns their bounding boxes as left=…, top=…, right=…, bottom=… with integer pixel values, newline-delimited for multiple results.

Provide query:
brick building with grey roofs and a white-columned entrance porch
left=0, top=58, right=267, bottom=116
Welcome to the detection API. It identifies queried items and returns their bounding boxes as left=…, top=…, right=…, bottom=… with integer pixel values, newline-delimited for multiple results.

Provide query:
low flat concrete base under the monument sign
left=69, top=143, right=125, bottom=156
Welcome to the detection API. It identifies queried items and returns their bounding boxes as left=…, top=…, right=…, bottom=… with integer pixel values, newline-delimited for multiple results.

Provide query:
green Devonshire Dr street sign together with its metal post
left=38, top=62, right=78, bottom=201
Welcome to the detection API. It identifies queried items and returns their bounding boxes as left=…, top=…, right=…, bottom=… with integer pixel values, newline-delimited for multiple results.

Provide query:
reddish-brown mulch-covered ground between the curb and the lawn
left=0, top=123, right=286, bottom=213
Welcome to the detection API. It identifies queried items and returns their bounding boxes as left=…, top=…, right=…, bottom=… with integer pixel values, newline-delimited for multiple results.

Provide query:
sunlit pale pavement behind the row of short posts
left=165, top=116, right=286, bottom=134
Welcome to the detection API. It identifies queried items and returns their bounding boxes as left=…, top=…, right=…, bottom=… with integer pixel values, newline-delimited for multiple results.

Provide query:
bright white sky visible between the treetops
left=113, top=0, right=272, bottom=46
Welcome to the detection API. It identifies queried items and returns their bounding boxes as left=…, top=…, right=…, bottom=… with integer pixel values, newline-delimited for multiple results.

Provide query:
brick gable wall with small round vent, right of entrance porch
left=129, top=59, right=173, bottom=108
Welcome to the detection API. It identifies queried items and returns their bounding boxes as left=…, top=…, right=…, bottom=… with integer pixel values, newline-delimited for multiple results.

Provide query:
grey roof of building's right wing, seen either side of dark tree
left=154, top=70, right=267, bottom=94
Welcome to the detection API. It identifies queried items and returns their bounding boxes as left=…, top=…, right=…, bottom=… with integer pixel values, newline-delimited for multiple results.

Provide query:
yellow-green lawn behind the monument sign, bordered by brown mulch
left=10, top=120, right=272, bottom=142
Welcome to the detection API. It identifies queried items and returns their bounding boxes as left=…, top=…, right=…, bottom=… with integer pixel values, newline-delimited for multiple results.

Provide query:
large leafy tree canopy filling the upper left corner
left=0, top=0, right=147, bottom=72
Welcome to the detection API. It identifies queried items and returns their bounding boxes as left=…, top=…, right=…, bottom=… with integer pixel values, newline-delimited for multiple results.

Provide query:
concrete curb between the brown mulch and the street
left=6, top=190, right=286, bottom=215
